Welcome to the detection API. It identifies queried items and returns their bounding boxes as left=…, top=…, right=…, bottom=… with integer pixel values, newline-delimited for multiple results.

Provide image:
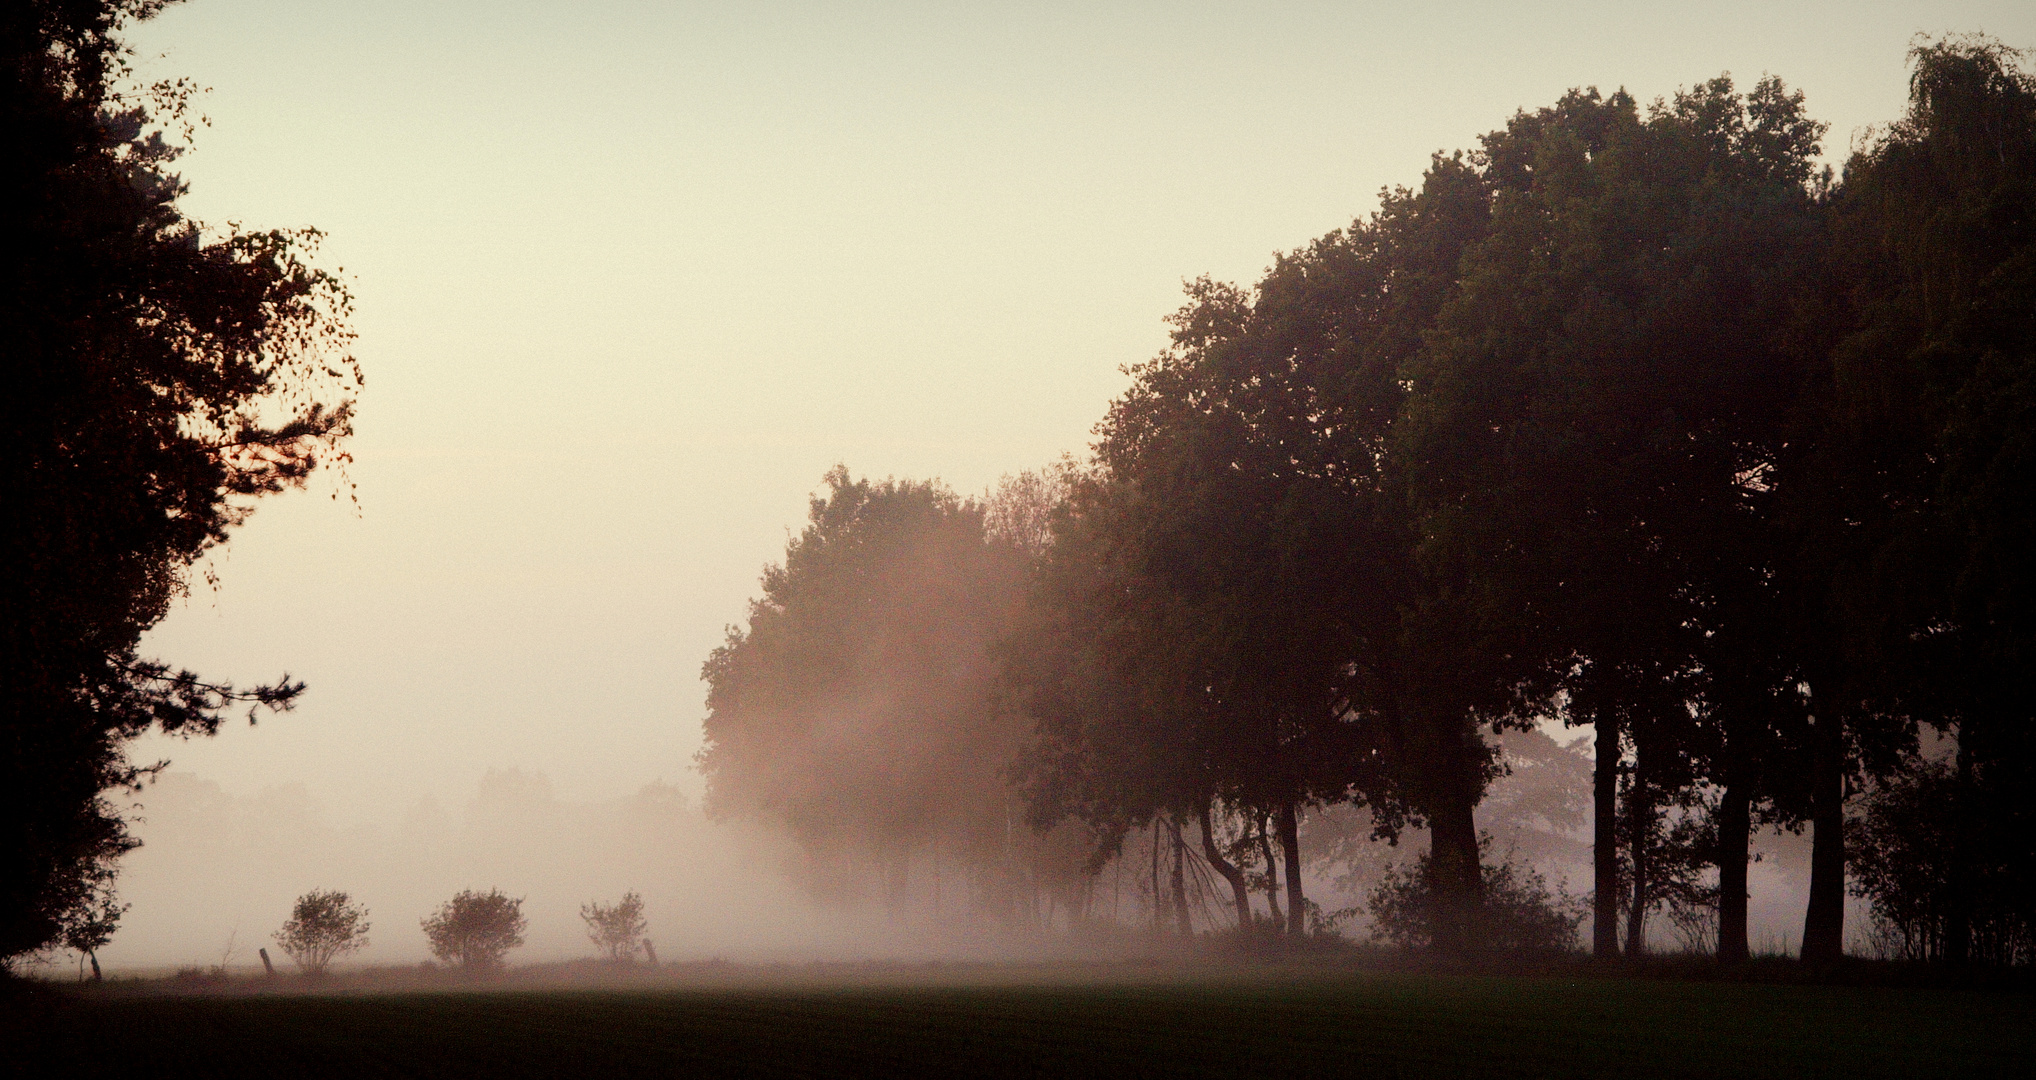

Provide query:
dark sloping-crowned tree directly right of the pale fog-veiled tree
left=1020, top=159, right=1490, bottom=943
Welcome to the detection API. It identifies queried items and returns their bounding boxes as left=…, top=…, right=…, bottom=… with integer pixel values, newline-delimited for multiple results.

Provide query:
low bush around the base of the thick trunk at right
left=1366, top=838, right=1590, bottom=952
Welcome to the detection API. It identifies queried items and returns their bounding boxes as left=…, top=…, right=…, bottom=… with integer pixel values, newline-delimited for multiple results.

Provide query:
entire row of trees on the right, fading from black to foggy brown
left=700, top=37, right=2036, bottom=964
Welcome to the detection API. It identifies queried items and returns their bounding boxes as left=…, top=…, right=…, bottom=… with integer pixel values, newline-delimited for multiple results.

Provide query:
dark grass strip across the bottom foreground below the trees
left=0, top=974, right=2036, bottom=1080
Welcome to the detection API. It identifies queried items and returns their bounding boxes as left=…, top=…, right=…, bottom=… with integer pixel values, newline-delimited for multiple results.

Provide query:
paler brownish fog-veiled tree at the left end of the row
left=698, top=467, right=1085, bottom=919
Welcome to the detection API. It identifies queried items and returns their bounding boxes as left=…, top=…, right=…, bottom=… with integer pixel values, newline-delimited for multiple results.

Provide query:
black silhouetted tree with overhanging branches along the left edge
left=0, top=0, right=360, bottom=958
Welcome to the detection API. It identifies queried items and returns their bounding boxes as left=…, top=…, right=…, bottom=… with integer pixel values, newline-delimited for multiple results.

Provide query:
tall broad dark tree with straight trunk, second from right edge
left=1399, top=77, right=1822, bottom=956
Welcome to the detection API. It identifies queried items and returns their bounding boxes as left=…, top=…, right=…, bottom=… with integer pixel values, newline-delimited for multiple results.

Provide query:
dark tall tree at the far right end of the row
left=1804, top=37, right=2036, bottom=962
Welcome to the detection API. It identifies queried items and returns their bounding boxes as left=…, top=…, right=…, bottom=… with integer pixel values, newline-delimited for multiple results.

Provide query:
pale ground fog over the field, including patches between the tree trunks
left=87, top=734, right=1832, bottom=974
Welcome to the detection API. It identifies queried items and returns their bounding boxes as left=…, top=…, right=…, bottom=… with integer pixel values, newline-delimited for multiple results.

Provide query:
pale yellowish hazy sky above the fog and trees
left=130, top=0, right=2036, bottom=823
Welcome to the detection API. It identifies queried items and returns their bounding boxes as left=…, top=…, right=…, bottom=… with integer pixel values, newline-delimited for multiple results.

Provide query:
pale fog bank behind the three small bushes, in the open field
left=102, top=770, right=967, bottom=970
